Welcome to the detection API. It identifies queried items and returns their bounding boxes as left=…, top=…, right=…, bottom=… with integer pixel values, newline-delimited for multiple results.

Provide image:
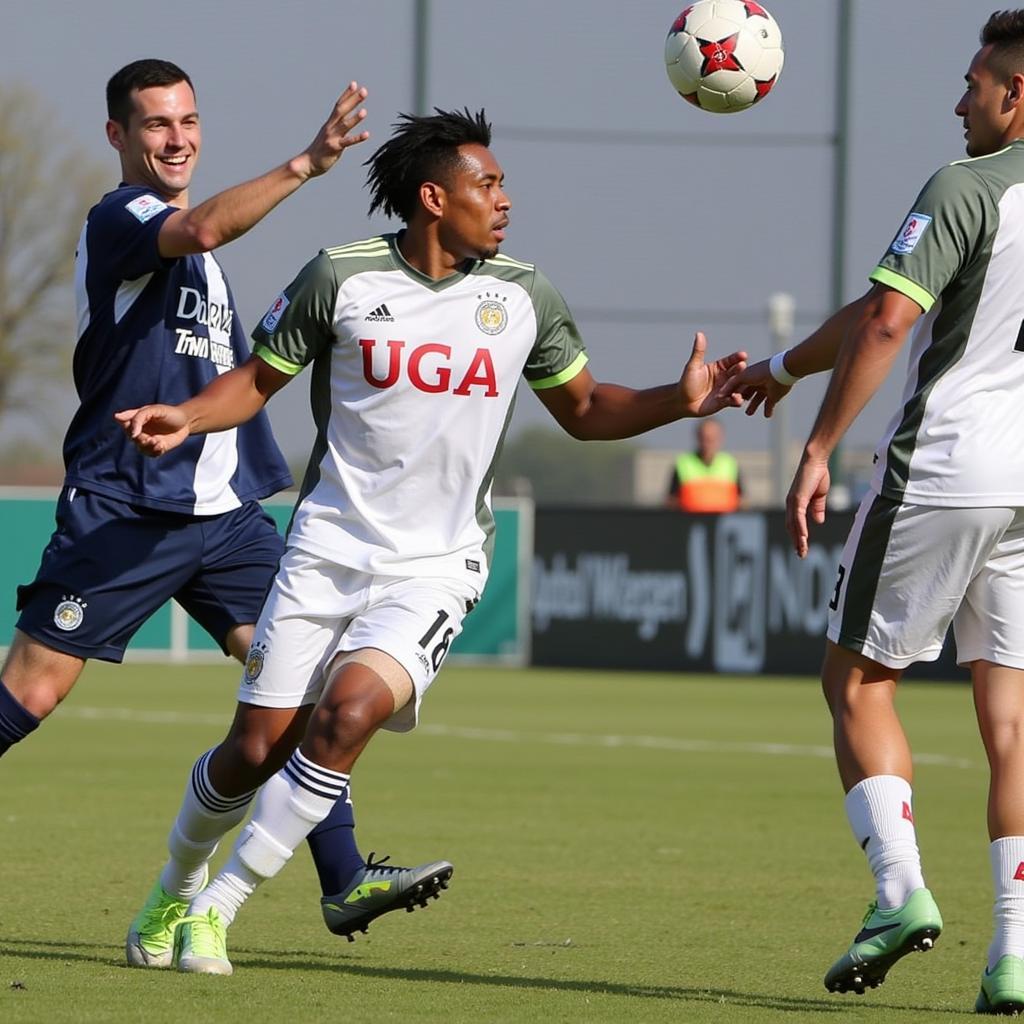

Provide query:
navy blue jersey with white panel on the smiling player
left=63, top=185, right=291, bottom=515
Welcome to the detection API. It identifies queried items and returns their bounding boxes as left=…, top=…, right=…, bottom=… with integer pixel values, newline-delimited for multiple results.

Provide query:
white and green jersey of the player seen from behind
left=870, top=140, right=1024, bottom=507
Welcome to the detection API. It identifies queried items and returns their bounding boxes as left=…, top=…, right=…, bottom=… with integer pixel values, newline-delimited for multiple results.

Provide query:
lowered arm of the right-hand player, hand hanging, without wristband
left=785, top=285, right=922, bottom=558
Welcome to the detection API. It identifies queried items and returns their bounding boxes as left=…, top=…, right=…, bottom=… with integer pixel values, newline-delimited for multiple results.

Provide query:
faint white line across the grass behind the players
left=56, top=706, right=977, bottom=769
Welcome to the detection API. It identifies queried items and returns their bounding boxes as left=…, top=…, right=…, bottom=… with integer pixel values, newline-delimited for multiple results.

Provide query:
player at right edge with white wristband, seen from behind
left=730, top=10, right=1024, bottom=1014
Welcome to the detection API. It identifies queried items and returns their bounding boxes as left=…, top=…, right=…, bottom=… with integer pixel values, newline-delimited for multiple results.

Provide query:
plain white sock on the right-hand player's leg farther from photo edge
left=846, top=775, right=925, bottom=910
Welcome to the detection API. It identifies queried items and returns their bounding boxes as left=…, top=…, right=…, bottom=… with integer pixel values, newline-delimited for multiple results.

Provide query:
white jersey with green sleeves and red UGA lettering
left=253, top=234, right=587, bottom=594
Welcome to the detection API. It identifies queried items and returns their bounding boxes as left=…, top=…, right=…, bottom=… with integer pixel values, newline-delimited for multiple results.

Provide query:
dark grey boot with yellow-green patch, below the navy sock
left=321, top=854, right=455, bottom=942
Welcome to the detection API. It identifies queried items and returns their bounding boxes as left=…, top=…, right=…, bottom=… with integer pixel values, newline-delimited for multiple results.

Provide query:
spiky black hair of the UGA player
left=366, top=106, right=490, bottom=224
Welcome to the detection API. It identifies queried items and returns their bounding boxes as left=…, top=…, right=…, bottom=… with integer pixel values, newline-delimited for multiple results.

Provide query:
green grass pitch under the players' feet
left=0, top=665, right=991, bottom=1024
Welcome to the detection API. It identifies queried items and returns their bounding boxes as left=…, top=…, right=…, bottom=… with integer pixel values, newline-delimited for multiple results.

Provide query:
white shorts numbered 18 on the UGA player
left=238, top=548, right=477, bottom=732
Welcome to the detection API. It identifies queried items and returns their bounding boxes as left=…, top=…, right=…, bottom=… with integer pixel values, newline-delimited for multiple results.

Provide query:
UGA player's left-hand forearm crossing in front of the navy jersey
left=114, top=355, right=292, bottom=456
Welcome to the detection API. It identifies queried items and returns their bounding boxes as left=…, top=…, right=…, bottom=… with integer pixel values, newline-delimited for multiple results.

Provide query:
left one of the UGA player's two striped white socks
left=160, top=751, right=256, bottom=899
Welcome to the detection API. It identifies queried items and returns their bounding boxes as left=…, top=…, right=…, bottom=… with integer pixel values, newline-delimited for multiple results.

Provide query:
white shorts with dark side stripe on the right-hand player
left=828, top=494, right=1024, bottom=669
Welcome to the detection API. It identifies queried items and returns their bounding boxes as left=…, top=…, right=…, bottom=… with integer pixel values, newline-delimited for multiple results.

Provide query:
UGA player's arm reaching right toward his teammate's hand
left=537, top=333, right=746, bottom=440
